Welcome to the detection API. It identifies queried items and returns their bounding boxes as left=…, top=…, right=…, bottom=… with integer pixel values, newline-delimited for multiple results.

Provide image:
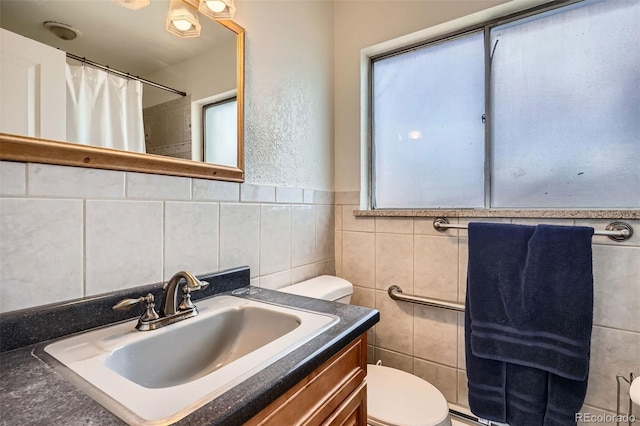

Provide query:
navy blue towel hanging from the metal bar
left=465, top=223, right=593, bottom=426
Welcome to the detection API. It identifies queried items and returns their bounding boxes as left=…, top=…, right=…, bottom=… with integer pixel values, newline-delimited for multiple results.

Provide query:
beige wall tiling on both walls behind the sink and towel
left=0, top=162, right=640, bottom=420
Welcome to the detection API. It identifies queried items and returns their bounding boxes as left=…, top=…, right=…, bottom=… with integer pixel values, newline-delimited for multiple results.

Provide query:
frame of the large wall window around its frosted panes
left=360, top=0, right=585, bottom=211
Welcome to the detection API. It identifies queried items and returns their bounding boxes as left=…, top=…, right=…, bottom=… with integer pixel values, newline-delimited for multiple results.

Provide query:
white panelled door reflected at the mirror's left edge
left=0, top=29, right=67, bottom=141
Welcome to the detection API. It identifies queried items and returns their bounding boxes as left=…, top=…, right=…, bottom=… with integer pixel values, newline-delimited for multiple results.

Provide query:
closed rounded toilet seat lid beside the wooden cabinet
left=367, top=364, right=451, bottom=426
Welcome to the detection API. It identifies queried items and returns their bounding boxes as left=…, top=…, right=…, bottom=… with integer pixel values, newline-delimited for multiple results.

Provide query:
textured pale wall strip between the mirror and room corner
left=235, top=1, right=333, bottom=190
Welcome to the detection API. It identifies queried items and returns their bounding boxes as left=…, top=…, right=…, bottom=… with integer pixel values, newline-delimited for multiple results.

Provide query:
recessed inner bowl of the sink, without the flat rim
left=104, top=305, right=301, bottom=388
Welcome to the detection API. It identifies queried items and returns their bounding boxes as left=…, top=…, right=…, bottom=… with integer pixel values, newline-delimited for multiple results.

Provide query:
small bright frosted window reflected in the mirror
left=202, top=98, right=238, bottom=167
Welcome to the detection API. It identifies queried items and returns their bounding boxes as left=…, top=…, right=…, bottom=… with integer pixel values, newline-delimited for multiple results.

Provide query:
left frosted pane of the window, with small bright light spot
left=372, top=33, right=484, bottom=208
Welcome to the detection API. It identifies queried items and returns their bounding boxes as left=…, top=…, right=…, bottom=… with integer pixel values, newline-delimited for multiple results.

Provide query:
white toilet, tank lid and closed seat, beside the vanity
left=278, top=275, right=451, bottom=426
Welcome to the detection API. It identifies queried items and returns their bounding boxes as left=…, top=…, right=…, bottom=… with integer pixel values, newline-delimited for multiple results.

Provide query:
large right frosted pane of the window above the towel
left=490, top=0, right=640, bottom=208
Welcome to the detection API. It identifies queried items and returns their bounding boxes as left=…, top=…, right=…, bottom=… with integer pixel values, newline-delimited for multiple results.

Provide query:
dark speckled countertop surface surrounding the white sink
left=0, top=270, right=379, bottom=426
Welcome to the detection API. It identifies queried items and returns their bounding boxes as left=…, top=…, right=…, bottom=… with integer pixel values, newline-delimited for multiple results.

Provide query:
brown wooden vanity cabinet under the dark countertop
left=246, top=333, right=367, bottom=426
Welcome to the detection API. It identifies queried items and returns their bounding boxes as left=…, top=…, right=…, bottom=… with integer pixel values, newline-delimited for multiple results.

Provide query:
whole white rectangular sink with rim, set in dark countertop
left=42, top=295, right=338, bottom=424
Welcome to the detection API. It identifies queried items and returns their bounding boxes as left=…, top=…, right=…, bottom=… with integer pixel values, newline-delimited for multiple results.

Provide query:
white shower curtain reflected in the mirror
left=66, top=65, right=145, bottom=152
